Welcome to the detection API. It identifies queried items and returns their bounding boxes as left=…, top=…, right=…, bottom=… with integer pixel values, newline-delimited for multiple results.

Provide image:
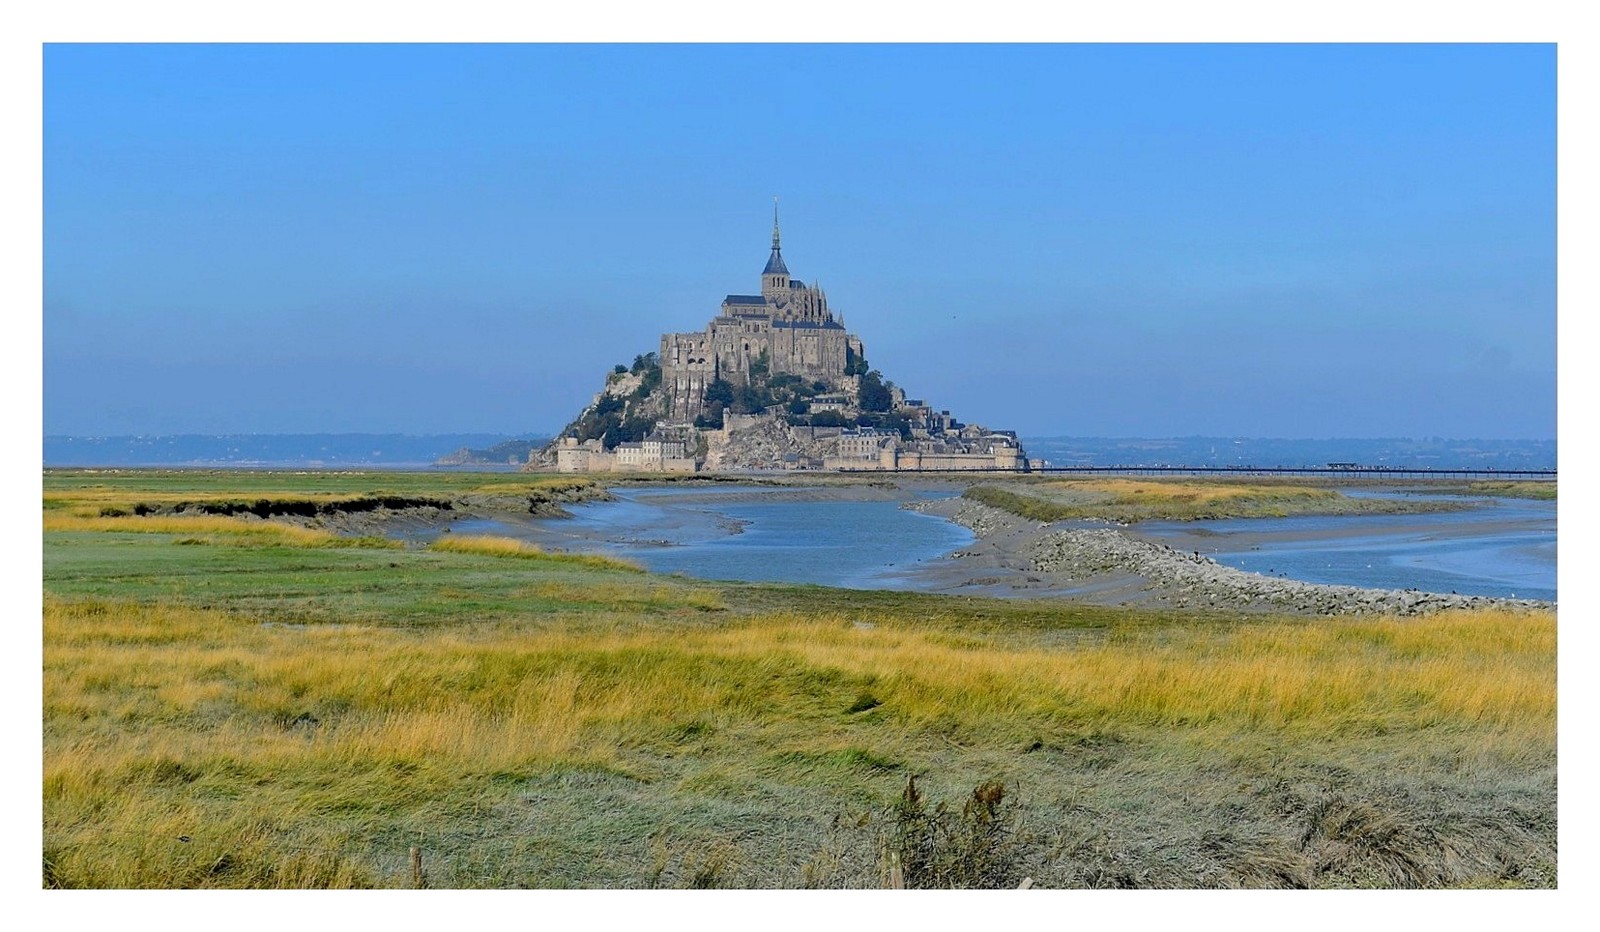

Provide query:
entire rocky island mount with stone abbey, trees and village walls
left=544, top=203, right=1029, bottom=472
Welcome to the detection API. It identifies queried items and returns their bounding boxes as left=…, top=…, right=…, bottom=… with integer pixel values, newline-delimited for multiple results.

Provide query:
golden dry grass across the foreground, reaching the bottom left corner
left=43, top=601, right=1555, bottom=886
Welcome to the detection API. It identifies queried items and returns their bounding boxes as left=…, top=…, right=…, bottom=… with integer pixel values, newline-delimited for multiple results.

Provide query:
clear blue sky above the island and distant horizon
left=43, top=45, right=1557, bottom=439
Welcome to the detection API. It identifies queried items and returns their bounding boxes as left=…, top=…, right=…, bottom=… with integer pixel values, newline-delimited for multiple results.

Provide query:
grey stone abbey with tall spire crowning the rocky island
left=661, top=203, right=864, bottom=421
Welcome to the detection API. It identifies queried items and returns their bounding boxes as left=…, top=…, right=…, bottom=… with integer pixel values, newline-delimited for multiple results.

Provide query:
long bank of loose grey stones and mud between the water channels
left=914, top=500, right=1552, bottom=615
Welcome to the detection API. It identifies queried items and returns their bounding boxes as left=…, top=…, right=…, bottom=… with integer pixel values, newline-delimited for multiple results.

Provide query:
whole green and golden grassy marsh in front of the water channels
left=42, top=471, right=1557, bottom=887
